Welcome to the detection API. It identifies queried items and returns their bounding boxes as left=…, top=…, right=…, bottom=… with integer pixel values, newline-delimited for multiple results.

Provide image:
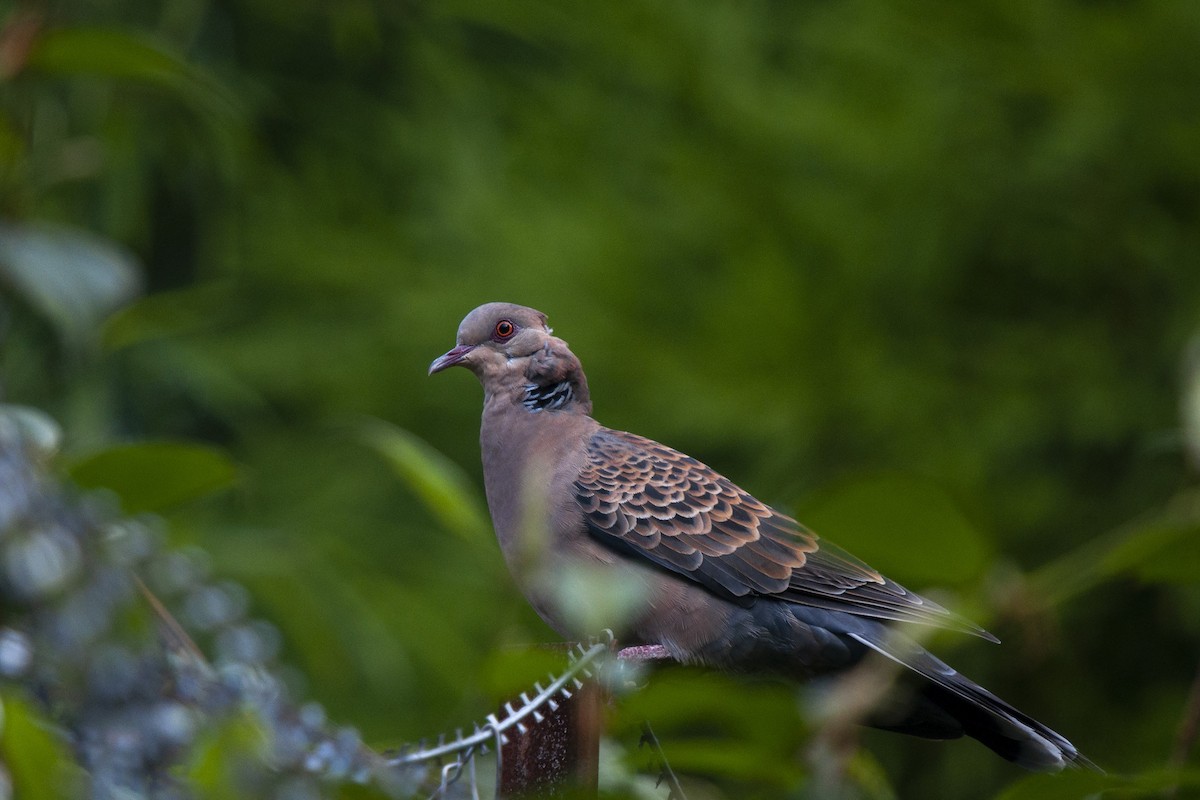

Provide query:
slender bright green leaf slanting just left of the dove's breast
left=361, top=420, right=492, bottom=542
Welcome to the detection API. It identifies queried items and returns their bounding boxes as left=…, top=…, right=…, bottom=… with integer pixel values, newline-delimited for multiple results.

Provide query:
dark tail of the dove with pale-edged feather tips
left=851, top=634, right=1096, bottom=772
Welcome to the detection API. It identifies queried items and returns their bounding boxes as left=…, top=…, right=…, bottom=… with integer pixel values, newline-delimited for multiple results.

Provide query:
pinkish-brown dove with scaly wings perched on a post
left=430, top=302, right=1092, bottom=771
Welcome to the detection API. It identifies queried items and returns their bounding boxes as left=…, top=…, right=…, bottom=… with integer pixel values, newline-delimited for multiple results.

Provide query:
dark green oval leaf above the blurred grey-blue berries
left=70, top=441, right=238, bottom=513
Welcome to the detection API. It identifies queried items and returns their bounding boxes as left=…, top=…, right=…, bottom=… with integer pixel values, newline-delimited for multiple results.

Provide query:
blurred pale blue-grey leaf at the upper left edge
left=0, top=222, right=142, bottom=343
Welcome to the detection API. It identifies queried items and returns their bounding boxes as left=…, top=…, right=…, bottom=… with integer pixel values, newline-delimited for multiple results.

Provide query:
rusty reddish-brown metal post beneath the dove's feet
left=496, top=662, right=602, bottom=800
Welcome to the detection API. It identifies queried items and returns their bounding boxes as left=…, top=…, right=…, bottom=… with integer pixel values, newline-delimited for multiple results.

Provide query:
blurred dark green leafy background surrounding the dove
left=0, top=0, right=1200, bottom=799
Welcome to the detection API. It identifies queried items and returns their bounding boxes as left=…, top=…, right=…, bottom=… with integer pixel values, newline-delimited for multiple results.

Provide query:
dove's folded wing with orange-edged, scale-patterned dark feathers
left=575, top=428, right=995, bottom=639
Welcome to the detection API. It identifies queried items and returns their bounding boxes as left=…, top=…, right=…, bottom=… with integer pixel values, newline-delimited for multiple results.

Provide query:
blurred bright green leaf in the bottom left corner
left=0, top=693, right=79, bottom=800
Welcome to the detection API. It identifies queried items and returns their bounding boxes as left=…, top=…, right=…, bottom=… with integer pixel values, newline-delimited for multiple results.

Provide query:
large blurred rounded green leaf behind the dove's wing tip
left=803, top=475, right=991, bottom=587
